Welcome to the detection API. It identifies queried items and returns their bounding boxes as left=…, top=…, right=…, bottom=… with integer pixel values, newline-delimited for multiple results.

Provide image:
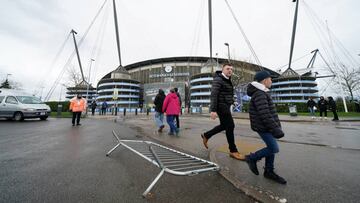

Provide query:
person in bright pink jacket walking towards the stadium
left=162, top=89, right=180, bottom=135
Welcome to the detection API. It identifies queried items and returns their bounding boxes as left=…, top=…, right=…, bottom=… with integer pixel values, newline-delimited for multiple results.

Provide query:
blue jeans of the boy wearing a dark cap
left=249, top=132, right=279, bottom=171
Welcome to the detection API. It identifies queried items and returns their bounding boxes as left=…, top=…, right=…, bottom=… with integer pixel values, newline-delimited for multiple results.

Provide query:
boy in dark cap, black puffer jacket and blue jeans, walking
left=245, top=71, right=286, bottom=184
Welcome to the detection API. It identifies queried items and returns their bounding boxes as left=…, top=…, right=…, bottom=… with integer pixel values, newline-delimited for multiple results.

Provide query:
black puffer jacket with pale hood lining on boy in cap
left=247, top=82, right=284, bottom=137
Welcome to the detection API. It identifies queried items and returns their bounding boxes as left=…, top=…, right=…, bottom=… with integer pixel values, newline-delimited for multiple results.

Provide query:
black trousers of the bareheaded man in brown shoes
left=204, top=106, right=238, bottom=152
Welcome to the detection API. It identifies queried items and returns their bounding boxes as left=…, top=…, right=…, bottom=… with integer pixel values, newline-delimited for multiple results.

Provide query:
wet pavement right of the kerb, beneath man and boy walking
left=125, top=116, right=360, bottom=202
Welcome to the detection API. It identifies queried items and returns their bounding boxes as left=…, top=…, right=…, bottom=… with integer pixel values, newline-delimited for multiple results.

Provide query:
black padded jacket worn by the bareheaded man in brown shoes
left=210, top=71, right=234, bottom=112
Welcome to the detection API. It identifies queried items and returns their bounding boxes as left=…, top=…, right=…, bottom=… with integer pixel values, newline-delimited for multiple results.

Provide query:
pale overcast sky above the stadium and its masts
left=0, top=0, right=360, bottom=100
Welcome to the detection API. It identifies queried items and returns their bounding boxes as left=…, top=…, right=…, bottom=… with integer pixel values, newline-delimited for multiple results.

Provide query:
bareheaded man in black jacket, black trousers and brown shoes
left=201, top=63, right=244, bottom=160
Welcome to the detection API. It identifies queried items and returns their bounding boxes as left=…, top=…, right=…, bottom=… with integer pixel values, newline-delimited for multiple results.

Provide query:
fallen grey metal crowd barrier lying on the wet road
left=106, top=131, right=220, bottom=197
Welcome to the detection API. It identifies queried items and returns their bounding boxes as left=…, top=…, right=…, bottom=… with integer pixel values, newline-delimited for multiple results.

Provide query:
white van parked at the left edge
left=0, top=89, right=51, bottom=121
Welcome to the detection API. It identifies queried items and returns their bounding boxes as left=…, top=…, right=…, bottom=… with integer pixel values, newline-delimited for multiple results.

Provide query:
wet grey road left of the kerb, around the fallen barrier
left=0, top=119, right=254, bottom=202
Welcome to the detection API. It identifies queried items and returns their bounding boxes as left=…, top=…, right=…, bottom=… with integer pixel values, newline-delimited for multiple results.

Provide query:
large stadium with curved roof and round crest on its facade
left=96, top=57, right=278, bottom=108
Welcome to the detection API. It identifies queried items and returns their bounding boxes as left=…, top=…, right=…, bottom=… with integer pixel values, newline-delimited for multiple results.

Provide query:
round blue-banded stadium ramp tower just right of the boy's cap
left=271, top=68, right=319, bottom=103
